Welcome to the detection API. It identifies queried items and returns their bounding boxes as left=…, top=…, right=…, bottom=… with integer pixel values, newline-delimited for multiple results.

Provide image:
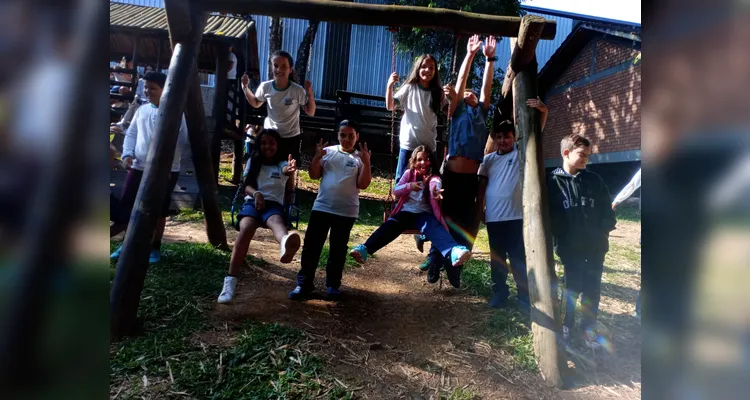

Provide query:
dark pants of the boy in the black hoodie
left=562, top=253, right=604, bottom=329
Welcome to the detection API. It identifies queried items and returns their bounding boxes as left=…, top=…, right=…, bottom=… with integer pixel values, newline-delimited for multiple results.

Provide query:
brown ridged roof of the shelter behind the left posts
left=109, top=2, right=252, bottom=39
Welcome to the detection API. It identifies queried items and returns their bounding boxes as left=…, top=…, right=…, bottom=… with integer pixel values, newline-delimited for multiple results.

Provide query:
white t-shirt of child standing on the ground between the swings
left=313, top=146, right=364, bottom=218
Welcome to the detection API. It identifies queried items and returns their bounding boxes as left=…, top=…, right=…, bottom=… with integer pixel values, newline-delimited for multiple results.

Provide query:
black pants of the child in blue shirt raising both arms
left=430, top=169, right=479, bottom=262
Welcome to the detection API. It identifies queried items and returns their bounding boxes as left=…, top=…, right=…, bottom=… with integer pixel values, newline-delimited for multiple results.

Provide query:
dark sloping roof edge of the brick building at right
left=538, top=21, right=641, bottom=94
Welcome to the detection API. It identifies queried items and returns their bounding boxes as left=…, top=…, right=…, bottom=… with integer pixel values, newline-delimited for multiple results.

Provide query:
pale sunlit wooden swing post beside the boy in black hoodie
left=512, top=17, right=568, bottom=388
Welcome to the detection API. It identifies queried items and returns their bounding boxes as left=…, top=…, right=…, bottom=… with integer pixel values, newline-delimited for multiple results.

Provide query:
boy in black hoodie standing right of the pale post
left=547, top=134, right=617, bottom=348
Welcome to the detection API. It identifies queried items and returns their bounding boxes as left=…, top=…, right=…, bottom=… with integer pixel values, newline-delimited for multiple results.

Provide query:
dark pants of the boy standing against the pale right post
left=487, top=219, right=529, bottom=304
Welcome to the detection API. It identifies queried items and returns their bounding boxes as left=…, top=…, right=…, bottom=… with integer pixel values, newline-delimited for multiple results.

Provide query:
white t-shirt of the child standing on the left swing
left=255, top=81, right=308, bottom=138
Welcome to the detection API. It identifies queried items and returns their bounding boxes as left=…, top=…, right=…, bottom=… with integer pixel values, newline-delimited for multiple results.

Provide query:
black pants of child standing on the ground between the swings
left=297, top=211, right=356, bottom=290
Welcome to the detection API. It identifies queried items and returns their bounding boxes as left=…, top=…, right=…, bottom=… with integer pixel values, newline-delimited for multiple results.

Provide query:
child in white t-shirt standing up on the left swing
left=241, top=51, right=315, bottom=160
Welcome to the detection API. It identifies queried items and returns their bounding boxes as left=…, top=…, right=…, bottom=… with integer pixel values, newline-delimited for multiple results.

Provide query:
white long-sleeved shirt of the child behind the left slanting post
left=122, top=103, right=188, bottom=172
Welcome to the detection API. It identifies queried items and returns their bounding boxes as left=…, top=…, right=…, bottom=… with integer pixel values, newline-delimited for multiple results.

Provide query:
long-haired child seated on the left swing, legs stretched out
left=218, top=129, right=301, bottom=303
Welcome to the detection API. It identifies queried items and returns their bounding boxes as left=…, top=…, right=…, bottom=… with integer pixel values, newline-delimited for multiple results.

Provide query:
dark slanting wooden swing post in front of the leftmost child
left=109, top=0, right=208, bottom=340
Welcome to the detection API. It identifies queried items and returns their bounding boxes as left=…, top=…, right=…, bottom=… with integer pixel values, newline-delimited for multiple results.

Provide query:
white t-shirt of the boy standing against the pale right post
left=477, top=147, right=523, bottom=222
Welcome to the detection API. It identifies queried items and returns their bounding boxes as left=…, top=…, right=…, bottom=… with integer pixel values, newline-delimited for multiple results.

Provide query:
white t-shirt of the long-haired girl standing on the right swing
left=393, top=83, right=448, bottom=151
